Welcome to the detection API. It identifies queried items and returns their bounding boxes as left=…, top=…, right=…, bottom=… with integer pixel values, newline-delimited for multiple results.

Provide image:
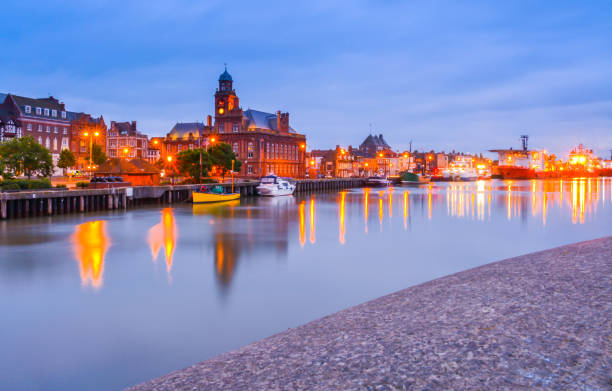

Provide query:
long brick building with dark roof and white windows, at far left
left=0, top=94, right=70, bottom=174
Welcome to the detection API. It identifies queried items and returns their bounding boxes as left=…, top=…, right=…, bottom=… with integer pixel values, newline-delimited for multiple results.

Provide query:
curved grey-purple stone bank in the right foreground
left=129, top=237, right=612, bottom=391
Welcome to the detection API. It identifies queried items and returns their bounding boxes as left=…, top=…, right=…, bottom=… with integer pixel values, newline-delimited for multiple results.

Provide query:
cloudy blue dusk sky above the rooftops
left=0, top=0, right=612, bottom=157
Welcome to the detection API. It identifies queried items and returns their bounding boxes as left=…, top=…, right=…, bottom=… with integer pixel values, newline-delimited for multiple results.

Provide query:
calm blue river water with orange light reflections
left=0, top=178, right=612, bottom=390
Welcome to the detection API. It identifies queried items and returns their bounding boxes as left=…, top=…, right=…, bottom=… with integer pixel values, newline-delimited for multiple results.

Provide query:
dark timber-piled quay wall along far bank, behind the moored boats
left=0, top=178, right=364, bottom=220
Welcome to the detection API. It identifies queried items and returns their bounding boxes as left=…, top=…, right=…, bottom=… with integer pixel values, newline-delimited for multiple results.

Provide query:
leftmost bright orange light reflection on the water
left=72, top=220, right=110, bottom=289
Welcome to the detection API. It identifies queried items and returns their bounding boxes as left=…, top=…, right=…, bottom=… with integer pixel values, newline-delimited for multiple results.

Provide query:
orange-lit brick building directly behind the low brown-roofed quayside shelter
left=106, top=121, right=149, bottom=159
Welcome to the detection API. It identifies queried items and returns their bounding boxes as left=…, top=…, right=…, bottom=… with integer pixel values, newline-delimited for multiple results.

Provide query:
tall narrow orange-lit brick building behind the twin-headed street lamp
left=68, top=112, right=107, bottom=170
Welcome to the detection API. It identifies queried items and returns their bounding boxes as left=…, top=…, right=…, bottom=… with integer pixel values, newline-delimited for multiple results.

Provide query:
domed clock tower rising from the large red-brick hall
left=215, top=67, right=242, bottom=133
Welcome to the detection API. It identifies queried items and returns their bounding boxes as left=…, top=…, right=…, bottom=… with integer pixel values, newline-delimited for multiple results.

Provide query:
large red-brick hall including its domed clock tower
left=208, top=69, right=306, bottom=178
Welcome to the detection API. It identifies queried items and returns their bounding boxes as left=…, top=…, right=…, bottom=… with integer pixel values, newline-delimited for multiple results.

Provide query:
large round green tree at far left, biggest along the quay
left=0, top=136, right=53, bottom=179
